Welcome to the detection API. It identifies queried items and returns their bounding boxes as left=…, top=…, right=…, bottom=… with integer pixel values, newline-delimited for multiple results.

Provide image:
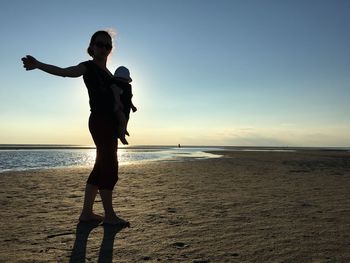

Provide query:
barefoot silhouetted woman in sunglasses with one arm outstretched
left=22, top=31, right=129, bottom=226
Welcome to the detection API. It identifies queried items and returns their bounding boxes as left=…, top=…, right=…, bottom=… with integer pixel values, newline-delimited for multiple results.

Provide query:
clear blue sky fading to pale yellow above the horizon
left=0, top=0, right=350, bottom=147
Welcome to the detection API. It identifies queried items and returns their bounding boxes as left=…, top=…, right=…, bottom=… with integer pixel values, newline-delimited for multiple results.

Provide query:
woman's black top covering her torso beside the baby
left=82, top=60, right=114, bottom=115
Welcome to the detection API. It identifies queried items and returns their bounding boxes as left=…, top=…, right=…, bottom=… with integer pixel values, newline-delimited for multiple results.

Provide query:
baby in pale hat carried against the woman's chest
left=111, top=66, right=137, bottom=144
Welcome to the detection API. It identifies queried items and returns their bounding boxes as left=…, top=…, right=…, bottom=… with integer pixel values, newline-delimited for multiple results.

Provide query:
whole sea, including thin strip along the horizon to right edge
left=0, top=144, right=350, bottom=173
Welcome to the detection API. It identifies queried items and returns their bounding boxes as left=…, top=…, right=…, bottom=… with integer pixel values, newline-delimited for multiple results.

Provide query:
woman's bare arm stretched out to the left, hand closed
left=22, top=55, right=86, bottom=78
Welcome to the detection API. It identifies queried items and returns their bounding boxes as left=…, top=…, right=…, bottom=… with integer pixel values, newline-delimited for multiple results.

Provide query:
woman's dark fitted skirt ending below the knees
left=87, top=113, right=118, bottom=190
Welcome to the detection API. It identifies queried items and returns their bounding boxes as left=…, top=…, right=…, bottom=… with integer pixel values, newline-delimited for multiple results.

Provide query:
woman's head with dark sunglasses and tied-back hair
left=87, top=30, right=112, bottom=58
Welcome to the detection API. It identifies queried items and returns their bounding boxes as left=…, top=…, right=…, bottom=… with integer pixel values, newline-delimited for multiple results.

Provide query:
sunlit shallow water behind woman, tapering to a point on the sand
left=0, top=146, right=220, bottom=173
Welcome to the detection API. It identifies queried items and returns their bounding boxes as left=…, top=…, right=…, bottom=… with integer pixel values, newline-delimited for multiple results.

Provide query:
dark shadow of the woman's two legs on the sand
left=69, top=222, right=125, bottom=263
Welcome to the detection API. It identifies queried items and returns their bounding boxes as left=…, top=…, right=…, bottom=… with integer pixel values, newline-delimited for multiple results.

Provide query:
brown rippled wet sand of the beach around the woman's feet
left=0, top=151, right=350, bottom=263
